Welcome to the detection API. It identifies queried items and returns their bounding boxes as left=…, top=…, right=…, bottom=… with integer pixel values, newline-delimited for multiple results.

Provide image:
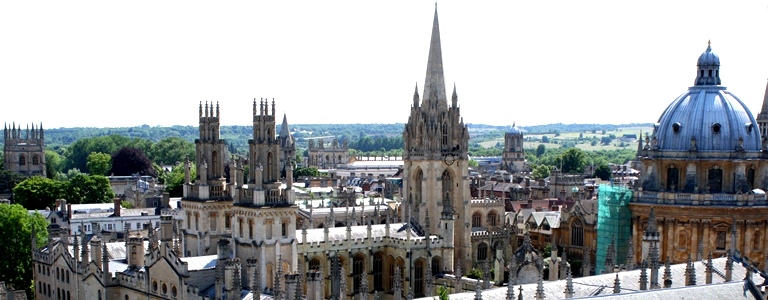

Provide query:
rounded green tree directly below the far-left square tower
left=13, top=176, right=66, bottom=209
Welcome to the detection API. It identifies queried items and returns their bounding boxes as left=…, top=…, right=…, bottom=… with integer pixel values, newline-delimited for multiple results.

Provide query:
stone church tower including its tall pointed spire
left=402, top=8, right=472, bottom=270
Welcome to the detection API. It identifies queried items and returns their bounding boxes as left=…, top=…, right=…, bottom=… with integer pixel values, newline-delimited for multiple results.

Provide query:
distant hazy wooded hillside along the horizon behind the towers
left=0, top=123, right=652, bottom=152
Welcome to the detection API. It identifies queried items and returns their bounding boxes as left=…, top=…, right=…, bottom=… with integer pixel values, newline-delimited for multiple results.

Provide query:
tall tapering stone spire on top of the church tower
left=421, top=4, right=448, bottom=108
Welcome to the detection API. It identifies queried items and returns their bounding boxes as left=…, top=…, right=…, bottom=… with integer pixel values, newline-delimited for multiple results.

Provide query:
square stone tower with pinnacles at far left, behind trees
left=3, top=123, right=45, bottom=177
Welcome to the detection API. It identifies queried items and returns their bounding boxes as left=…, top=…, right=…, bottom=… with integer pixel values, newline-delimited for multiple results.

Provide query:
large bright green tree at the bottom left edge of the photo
left=0, top=204, right=48, bottom=295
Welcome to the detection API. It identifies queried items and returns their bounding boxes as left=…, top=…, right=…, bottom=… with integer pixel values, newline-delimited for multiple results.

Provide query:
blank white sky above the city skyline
left=0, top=0, right=768, bottom=128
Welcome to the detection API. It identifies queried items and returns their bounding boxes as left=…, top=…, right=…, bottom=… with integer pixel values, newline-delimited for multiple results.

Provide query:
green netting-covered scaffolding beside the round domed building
left=595, top=184, right=632, bottom=274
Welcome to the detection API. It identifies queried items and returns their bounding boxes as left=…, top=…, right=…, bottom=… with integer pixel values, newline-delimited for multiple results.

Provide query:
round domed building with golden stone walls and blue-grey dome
left=629, top=41, right=768, bottom=268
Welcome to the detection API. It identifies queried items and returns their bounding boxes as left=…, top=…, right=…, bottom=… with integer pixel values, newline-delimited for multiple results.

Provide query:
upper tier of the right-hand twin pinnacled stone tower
left=248, top=99, right=280, bottom=188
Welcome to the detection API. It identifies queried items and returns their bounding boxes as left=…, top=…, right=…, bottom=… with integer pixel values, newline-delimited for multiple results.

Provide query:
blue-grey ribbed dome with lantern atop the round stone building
left=654, top=45, right=761, bottom=151
